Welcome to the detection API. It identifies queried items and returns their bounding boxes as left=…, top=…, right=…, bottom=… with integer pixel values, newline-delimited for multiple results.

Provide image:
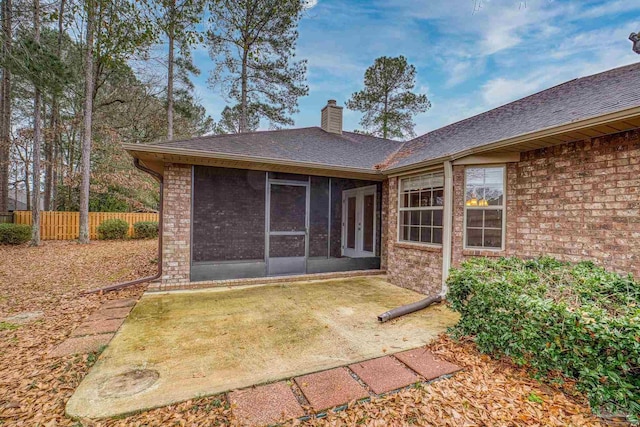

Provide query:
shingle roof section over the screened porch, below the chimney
left=148, top=127, right=402, bottom=170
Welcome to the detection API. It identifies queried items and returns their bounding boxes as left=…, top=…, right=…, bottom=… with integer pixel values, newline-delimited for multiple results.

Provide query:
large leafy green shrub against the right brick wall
left=447, top=258, right=640, bottom=421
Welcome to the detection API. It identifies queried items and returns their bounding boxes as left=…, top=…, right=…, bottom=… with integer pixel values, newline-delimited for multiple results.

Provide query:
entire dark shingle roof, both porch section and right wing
left=134, top=63, right=640, bottom=170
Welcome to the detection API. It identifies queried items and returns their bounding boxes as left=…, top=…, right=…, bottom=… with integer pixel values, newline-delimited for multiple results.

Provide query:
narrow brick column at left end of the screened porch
left=162, top=163, right=191, bottom=285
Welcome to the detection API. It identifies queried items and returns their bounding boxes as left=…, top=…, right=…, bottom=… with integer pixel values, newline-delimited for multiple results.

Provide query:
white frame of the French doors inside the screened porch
left=341, top=185, right=378, bottom=258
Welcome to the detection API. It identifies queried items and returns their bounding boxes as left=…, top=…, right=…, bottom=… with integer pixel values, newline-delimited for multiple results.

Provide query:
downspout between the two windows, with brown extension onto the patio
left=378, top=161, right=453, bottom=323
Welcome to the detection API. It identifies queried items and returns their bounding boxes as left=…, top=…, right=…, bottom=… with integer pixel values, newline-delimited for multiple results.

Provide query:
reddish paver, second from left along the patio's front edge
left=295, top=368, right=369, bottom=411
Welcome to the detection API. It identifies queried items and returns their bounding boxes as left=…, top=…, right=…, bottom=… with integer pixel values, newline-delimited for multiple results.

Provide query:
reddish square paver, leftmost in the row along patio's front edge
left=229, top=382, right=304, bottom=426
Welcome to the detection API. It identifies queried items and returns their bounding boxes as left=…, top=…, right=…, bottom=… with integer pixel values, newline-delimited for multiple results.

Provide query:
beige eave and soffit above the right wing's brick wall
left=382, top=106, right=640, bottom=176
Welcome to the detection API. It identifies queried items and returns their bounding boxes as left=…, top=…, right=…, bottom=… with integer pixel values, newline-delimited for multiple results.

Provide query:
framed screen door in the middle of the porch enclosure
left=267, top=180, right=310, bottom=276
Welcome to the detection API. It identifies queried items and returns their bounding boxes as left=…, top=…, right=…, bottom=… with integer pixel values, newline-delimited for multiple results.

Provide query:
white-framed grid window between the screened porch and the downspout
left=398, top=172, right=444, bottom=245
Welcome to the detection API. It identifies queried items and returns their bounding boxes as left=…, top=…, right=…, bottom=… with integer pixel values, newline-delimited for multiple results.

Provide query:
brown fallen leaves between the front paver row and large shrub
left=289, top=335, right=602, bottom=427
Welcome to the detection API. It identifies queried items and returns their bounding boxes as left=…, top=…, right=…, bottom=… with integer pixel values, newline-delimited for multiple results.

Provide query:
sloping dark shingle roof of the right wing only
left=386, top=63, right=640, bottom=169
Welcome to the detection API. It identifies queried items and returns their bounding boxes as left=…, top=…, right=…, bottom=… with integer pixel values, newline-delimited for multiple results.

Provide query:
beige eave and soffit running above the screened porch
left=122, top=144, right=385, bottom=181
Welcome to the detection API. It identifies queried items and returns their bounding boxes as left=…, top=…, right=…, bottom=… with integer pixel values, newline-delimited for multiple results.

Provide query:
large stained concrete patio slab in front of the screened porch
left=67, top=276, right=458, bottom=418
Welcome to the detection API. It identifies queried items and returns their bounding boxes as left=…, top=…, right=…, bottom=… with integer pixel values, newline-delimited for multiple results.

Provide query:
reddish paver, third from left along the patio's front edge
left=349, top=356, right=420, bottom=394
